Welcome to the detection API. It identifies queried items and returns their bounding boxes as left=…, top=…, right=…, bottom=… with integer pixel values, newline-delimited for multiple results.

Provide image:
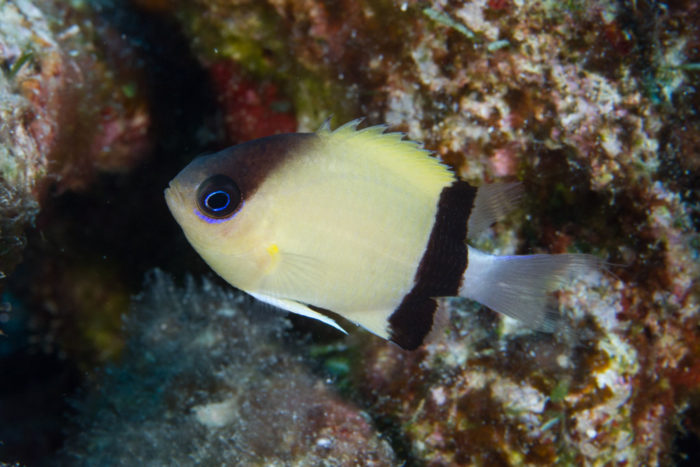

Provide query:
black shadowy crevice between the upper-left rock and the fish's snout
left=0, top=1, right=220, bottom=465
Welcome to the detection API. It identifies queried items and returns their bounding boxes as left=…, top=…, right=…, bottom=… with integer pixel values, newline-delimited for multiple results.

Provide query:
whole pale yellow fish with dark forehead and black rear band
left=165, top=120, right=601, bottom=350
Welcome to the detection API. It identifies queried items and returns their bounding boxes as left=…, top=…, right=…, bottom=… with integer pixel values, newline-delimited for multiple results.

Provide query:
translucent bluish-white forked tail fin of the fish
left=459, top=247, right=603, bottom=332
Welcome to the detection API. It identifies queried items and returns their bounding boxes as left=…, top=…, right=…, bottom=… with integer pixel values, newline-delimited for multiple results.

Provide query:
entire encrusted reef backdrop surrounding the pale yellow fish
left=0, top=0, right=700, bottom=465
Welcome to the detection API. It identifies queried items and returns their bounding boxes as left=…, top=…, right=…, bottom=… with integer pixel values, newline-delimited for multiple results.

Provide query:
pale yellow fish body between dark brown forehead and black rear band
left=168, top=125, right=454, bottom=337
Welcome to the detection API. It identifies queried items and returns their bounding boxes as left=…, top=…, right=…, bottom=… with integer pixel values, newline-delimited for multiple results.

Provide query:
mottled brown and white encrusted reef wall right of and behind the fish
left=163, top=0, right=700, bottom=465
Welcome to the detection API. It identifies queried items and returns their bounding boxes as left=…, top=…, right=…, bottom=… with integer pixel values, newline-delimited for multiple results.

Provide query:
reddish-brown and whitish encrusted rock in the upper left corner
left=0, top=0, right=150, bottom=284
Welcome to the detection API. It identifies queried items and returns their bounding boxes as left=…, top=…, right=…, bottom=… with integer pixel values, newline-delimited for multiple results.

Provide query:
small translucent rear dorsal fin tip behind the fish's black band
left=467, top=182, right=523, bottom=238
